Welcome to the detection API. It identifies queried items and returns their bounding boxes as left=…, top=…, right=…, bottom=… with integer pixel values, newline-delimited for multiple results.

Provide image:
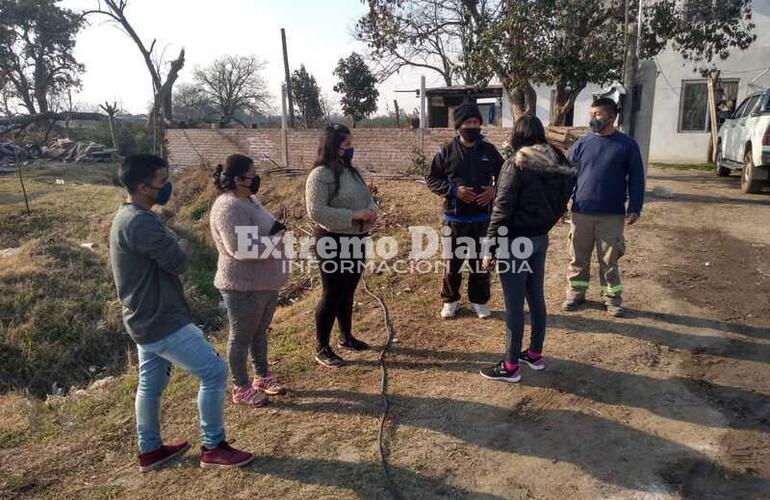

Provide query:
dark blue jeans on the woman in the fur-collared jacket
left=499, top=234, right=548, bottom=363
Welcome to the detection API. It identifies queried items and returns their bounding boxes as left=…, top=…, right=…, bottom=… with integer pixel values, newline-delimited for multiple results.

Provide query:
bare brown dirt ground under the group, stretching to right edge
left=0, top=164, right=770, bottom=499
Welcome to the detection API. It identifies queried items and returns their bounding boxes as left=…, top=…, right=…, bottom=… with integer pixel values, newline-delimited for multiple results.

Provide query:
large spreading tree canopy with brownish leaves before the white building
left=358, top=0, right=756, bottom=123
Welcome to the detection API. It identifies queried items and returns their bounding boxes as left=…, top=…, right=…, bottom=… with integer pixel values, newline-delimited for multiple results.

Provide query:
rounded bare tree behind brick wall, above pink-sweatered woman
left=195, top=55, right=270, bottom=127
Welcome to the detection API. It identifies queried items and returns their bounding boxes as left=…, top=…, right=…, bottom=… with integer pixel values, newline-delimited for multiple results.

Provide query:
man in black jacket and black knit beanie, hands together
left=425, top=103, right=503, bottom=319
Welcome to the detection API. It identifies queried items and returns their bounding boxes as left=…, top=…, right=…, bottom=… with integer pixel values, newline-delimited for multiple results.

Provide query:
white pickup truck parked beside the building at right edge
left=714, top=89, right=770, bottom=193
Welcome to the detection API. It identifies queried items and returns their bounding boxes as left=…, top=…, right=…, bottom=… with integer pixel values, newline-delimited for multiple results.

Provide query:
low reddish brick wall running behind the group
left=168, top=127, right=511, bottom=174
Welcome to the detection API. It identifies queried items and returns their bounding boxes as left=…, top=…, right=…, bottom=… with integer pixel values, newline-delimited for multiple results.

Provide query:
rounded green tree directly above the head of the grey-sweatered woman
left=334, top=52, right=380, bottom=127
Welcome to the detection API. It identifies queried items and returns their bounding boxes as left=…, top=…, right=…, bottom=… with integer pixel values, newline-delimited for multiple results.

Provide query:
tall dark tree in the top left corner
left=0, top=0, right=84, bottom=114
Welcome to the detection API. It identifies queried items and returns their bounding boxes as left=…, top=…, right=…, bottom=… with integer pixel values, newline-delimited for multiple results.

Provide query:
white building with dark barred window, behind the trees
left=502, top=0, right=770, bottom=163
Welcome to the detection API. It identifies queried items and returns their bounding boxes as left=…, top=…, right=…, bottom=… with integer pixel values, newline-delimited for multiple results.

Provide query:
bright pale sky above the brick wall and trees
left=61, top=0, right=450, bottom=114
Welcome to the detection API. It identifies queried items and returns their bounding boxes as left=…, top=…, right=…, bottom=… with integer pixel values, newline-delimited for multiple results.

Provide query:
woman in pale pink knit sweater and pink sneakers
left=210, top=154, right=288, bottom=407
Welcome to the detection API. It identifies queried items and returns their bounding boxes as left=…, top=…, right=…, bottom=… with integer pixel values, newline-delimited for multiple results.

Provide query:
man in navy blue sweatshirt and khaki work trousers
left=562, top=98, right=645, bottom=317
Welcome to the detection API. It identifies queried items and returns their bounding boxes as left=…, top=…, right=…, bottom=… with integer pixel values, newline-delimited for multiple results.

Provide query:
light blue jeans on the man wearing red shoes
left=136, top=323, right=227, bottom=453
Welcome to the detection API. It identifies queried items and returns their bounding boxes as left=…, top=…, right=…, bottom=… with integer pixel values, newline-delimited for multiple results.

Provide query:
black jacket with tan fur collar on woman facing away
left=487, top=144, right=577, bottom=238
